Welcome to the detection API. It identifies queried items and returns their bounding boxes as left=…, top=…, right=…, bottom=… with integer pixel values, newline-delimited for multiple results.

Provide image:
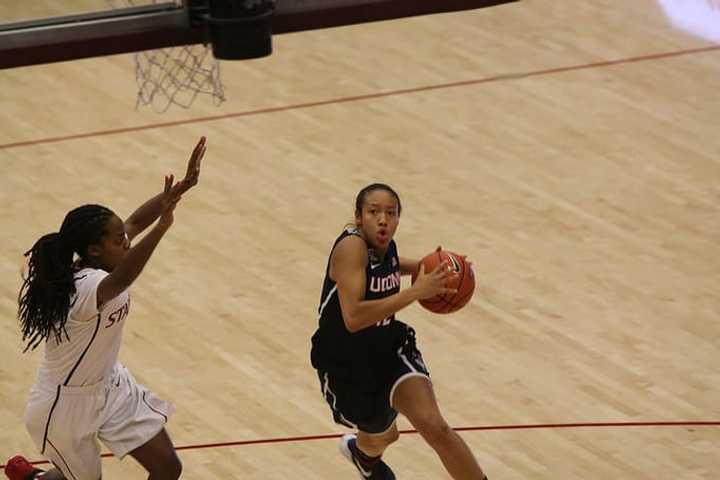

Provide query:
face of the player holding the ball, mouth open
left=355, top=190, right=400, bottom=252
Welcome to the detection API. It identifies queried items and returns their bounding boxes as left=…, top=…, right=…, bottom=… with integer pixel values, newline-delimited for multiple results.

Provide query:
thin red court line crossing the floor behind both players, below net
left=0, top=45, right=720, bottom=150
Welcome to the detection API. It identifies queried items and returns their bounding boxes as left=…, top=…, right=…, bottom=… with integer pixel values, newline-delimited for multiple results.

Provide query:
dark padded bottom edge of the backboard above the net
left=0, top=0, right=516, bottom=68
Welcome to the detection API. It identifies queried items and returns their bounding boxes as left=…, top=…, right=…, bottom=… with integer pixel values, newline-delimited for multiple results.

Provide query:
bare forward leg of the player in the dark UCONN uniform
left=391, top=376, right=486, bottom=480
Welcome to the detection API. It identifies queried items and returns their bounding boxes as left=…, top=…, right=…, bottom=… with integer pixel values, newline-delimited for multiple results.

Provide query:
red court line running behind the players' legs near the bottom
left=0, top=421, right=720, bottom=469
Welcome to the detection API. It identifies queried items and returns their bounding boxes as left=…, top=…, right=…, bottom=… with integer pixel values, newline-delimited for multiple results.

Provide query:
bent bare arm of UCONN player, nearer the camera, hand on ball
left=330, top=236, right=451, bottom=333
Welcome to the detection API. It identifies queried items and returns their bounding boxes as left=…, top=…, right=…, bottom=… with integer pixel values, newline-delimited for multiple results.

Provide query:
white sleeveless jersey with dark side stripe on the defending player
left=37, top=268, right=130, bottom=390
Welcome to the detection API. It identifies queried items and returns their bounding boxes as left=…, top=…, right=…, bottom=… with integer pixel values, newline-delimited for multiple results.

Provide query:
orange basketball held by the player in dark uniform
left=412, top=250, right=475, bottom=313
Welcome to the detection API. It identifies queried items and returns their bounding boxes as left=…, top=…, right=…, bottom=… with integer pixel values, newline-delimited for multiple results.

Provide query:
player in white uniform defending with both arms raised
left=5, top=137, right=205, bottom=480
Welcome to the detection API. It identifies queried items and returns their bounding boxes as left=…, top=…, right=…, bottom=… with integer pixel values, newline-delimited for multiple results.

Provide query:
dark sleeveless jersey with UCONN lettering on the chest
left=311, top=228, right=407, bottom=386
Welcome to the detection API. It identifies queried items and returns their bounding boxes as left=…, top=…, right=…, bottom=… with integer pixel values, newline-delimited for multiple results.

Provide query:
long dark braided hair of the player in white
left=18, top=205, right=114, bottom=352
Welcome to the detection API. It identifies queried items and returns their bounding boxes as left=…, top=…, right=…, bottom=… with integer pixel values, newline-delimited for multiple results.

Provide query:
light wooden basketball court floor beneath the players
left=0, top=0, right=720, bottom=480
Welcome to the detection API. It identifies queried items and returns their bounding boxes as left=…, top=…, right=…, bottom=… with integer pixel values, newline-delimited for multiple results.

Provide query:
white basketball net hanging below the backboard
left=107, top=0, right=225, bottom=113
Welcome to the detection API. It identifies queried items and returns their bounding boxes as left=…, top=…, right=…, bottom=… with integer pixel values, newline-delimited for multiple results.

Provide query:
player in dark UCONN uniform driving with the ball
left=311, top=184, right=486, bottom=480
